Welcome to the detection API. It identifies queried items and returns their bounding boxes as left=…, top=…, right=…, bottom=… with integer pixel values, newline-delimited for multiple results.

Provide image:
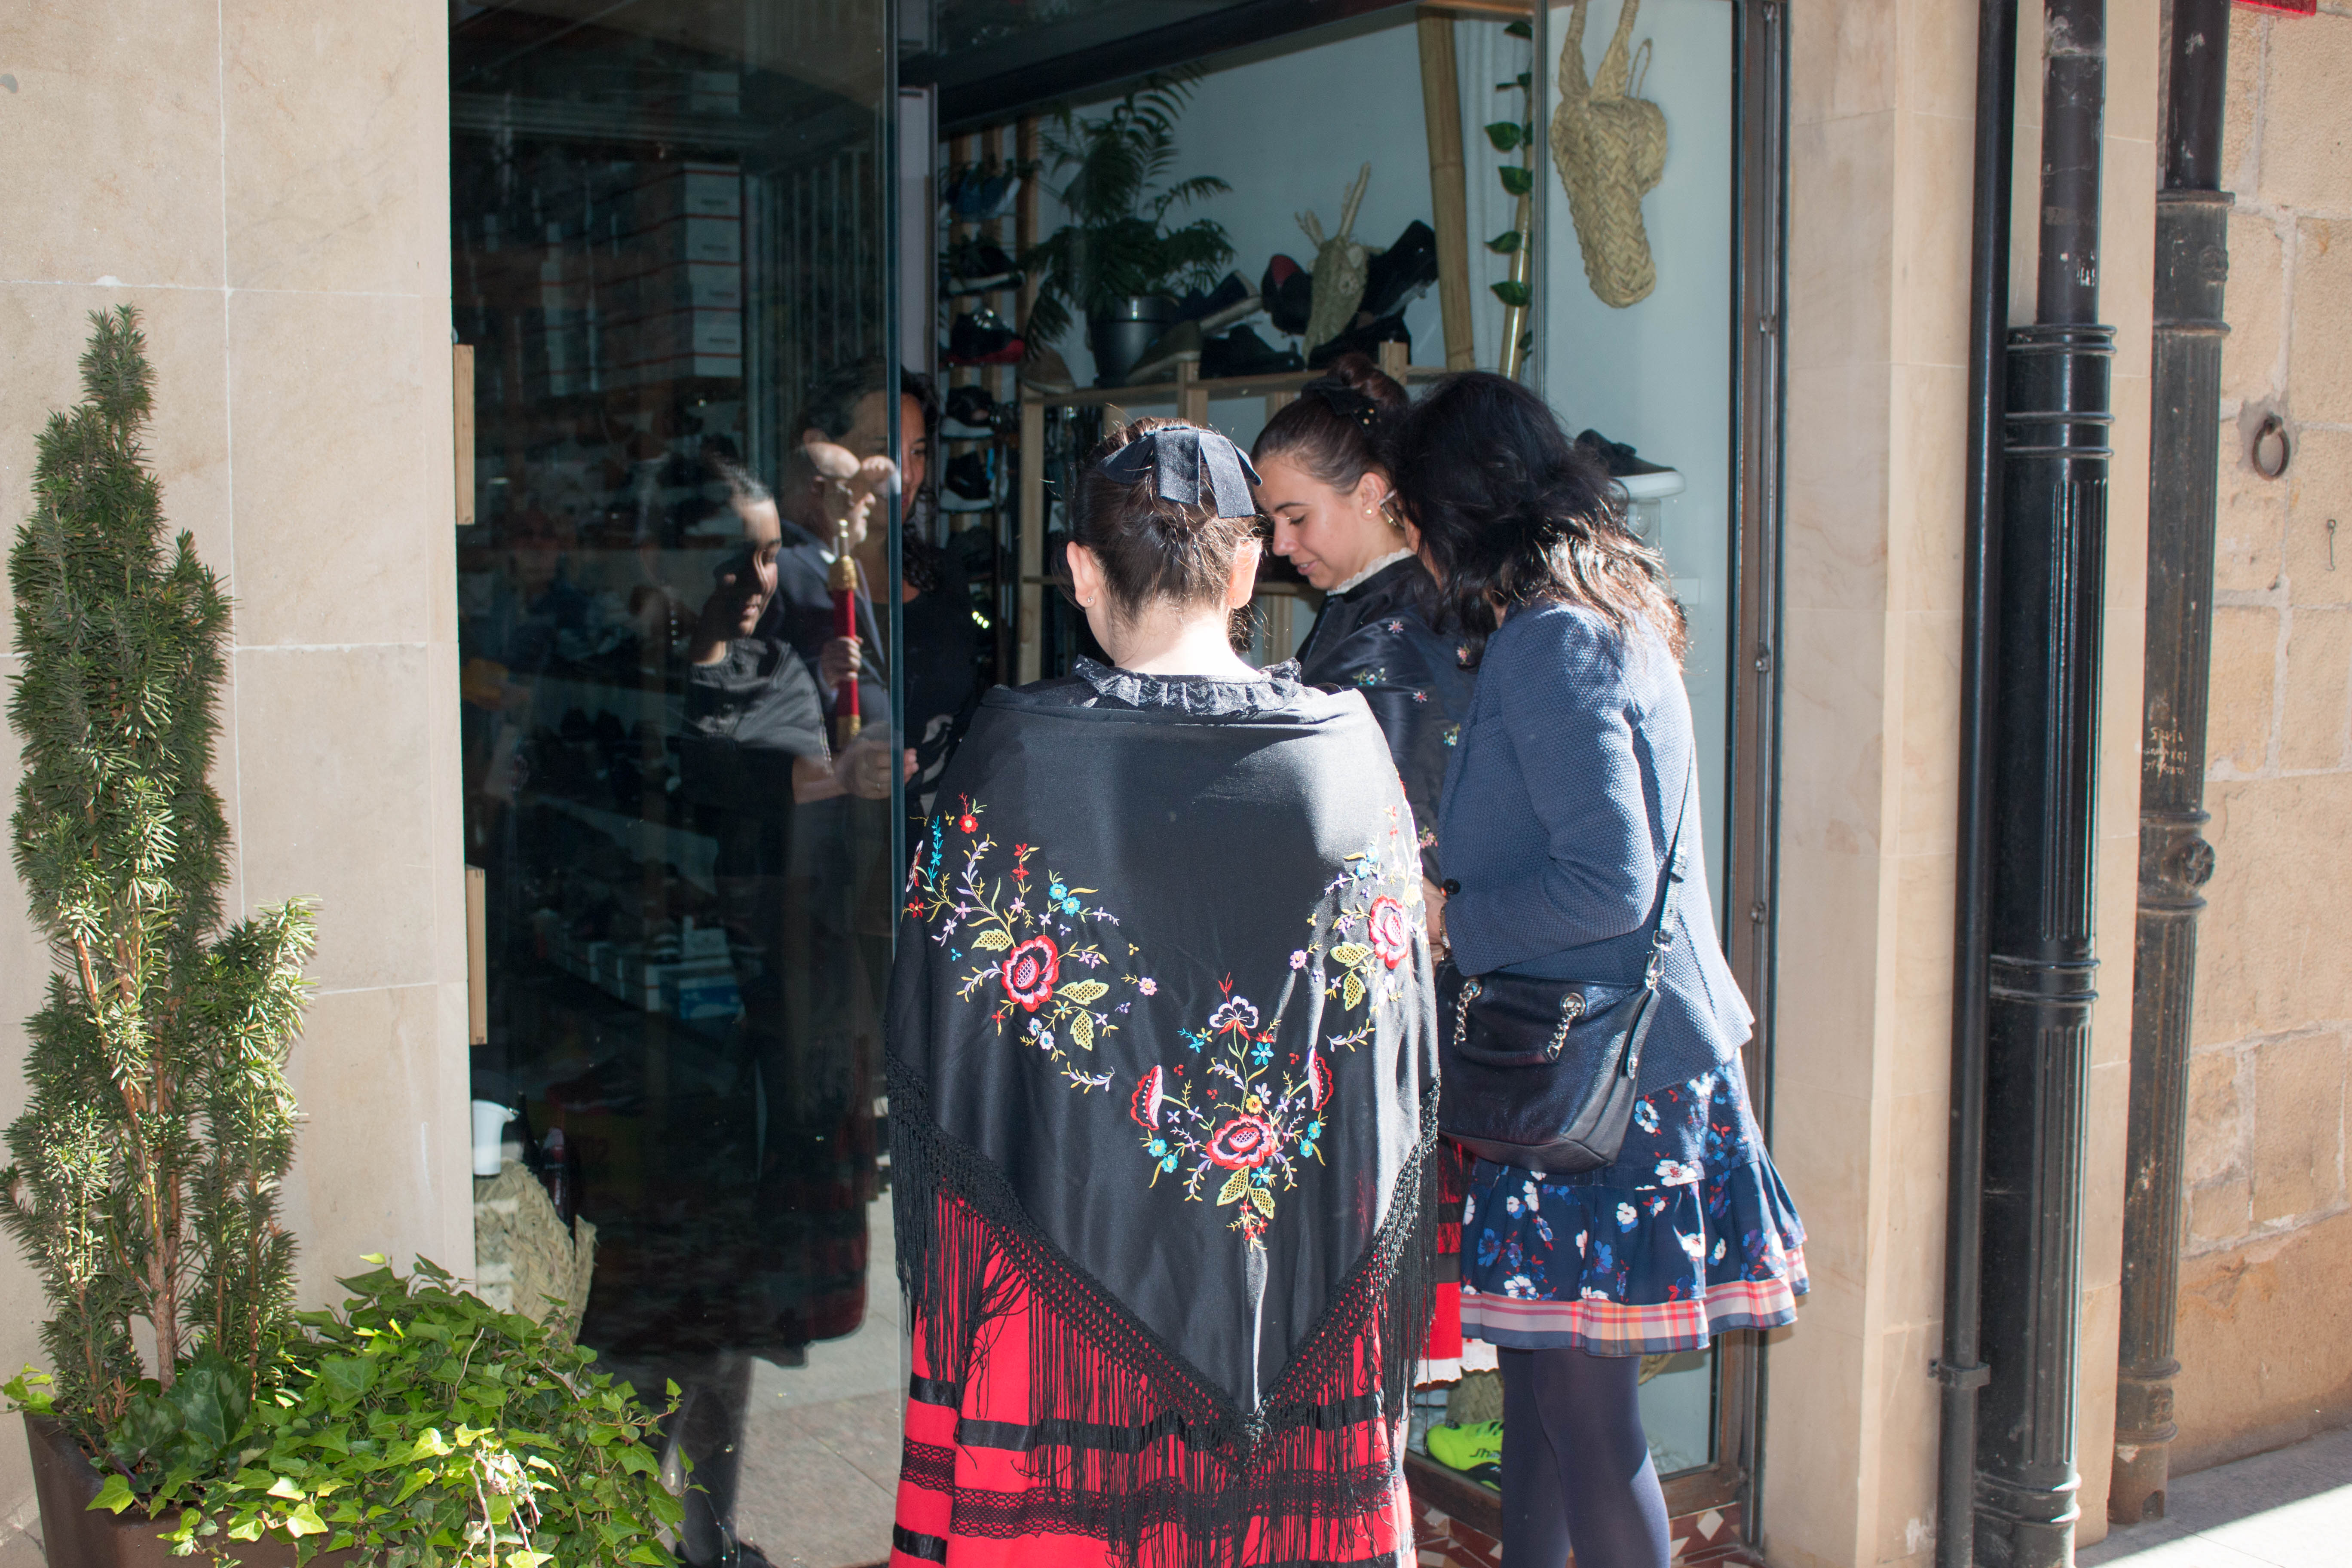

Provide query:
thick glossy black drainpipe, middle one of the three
left=1973, top=0, right=2114, bottom=1568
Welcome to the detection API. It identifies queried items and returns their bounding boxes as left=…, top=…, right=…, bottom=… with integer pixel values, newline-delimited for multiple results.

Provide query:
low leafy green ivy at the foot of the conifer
left=64, top=1258, right=684, bottom=1568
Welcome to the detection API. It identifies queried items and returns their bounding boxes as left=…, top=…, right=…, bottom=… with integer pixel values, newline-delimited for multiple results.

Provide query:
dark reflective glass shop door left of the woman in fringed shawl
left=449, top=0, right=922, bottom=1568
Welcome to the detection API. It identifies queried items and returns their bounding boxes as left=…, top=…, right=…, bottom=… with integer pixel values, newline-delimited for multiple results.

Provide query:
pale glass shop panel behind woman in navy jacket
left=1496, top=0, right=1802, bottom=1523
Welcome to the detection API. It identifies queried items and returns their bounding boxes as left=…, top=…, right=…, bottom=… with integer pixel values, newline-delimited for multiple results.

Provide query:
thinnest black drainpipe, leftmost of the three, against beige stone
left=1933, top=0, right=2018, bottom=1568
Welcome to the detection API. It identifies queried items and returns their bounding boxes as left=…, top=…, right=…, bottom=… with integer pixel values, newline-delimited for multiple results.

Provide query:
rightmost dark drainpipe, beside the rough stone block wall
left=2107, top=0, right=2230, bottom=1523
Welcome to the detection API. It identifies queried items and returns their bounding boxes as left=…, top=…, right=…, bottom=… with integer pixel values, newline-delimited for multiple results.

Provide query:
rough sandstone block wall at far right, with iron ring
left=2173, top=0, right=2352, bottom=1472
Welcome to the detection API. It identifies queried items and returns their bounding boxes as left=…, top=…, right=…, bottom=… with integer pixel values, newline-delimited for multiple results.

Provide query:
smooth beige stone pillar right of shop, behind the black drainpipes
left=1762, top=0, right=2157, bottom=1568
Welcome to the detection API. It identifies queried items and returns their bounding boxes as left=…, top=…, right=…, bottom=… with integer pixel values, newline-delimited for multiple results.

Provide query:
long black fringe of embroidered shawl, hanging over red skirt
left=889, top=1056, right=1439, bottom=1568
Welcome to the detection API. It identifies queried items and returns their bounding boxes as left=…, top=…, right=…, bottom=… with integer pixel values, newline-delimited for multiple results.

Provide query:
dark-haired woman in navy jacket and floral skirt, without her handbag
left=1395, top=374, right=1804, bottom=1568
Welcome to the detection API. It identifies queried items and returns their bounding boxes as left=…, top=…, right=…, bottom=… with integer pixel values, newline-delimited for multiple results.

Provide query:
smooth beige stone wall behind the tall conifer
left=0, top=0, right=473, bottom=1563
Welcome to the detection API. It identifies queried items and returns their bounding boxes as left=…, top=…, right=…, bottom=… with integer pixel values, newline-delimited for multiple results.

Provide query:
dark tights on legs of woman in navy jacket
left=1498, top=1349, right=1668, bottom=1568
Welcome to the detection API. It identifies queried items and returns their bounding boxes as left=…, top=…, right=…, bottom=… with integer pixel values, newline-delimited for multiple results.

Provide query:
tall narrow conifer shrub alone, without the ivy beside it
left=0, top=308, right=313, bottom=1563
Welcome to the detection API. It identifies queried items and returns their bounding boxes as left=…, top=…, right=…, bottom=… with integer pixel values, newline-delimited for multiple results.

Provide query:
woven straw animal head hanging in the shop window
left=1553, top=0, right=1665, bottom=310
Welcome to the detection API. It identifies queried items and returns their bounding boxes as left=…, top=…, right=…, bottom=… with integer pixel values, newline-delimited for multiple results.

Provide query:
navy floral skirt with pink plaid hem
left=1463, top=1063, right=1806, bottom=1357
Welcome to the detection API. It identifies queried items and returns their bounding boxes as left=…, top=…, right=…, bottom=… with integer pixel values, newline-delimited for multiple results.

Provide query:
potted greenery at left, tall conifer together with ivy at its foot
left=0, top=308, right=682, bottom=1568
